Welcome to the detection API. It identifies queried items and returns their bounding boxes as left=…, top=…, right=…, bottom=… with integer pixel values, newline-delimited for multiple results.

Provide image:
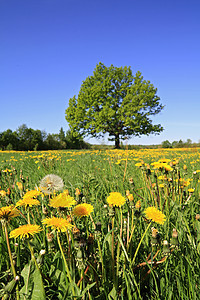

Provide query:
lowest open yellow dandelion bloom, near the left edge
left=10, top=224, right=42, bottom=239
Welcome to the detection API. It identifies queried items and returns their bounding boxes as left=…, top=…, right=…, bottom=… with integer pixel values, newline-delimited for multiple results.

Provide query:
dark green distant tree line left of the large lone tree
left=0, top=124, right=90, bottom=151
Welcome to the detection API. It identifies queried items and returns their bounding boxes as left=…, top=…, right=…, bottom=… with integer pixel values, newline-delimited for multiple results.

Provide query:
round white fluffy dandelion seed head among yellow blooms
left=39, top=174, right=64, bottom=194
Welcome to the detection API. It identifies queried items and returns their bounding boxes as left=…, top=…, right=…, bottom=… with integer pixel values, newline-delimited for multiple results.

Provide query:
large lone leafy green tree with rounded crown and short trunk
left=66, top=63, right=163, bottom=148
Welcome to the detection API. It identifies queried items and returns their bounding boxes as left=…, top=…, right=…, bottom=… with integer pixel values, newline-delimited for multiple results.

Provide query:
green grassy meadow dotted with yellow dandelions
left=0, top=148, right=200, bottom=300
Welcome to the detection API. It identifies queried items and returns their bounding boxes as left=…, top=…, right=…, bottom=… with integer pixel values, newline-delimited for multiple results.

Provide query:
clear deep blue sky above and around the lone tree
left=0, top=0, right=200, bottom=144
